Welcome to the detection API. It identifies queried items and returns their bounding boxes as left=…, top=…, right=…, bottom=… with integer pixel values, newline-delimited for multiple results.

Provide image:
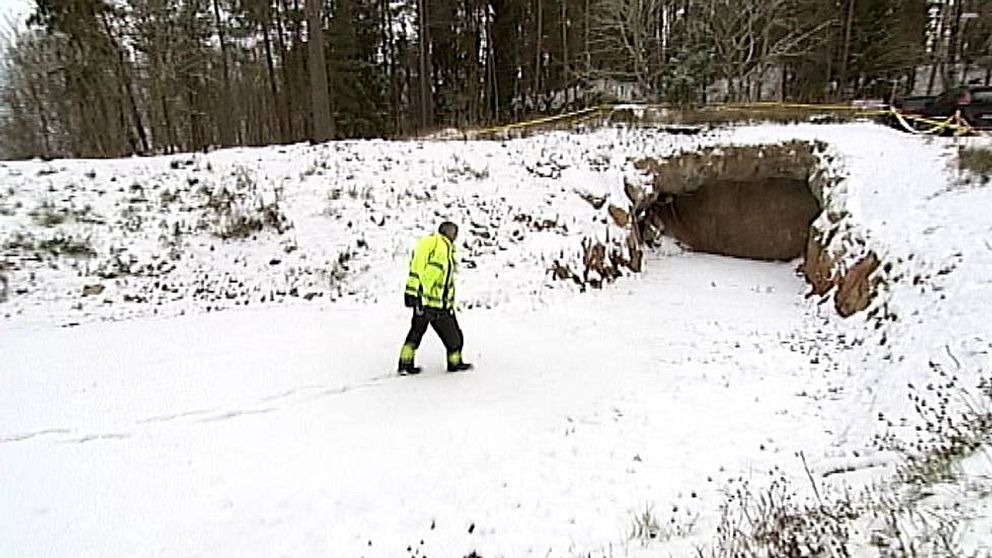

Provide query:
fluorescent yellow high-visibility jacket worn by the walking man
left=406, top=233, right=455, bottom=310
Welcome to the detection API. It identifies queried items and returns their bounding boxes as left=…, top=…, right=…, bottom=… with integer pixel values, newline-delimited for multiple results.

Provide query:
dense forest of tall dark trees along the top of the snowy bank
left=0, top=0, right=992, bottom=158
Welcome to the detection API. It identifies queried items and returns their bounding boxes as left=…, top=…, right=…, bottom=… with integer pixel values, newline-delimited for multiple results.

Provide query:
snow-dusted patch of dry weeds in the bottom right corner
left=705, top=364, right=992, bottom=558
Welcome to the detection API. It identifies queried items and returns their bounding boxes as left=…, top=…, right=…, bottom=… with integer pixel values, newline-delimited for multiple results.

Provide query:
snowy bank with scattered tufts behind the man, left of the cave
left=2, top=133, right=674, bottom=323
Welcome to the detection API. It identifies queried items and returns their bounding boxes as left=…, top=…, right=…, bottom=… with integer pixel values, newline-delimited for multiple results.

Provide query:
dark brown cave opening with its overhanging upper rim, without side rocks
left=640, top=142, right=822, bottom=261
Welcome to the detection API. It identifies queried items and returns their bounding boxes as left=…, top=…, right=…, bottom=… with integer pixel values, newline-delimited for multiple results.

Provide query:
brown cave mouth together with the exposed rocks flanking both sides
left=568, top=141, right=880, bottom=317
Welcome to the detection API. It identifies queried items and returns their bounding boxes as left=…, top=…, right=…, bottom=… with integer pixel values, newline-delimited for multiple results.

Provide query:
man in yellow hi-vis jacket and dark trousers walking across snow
left=399, top=221, right=472, bottom=374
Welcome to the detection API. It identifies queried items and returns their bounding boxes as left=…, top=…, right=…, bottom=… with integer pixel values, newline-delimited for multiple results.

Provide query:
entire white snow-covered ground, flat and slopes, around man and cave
left=0, top=124, right=992, bottom=558
